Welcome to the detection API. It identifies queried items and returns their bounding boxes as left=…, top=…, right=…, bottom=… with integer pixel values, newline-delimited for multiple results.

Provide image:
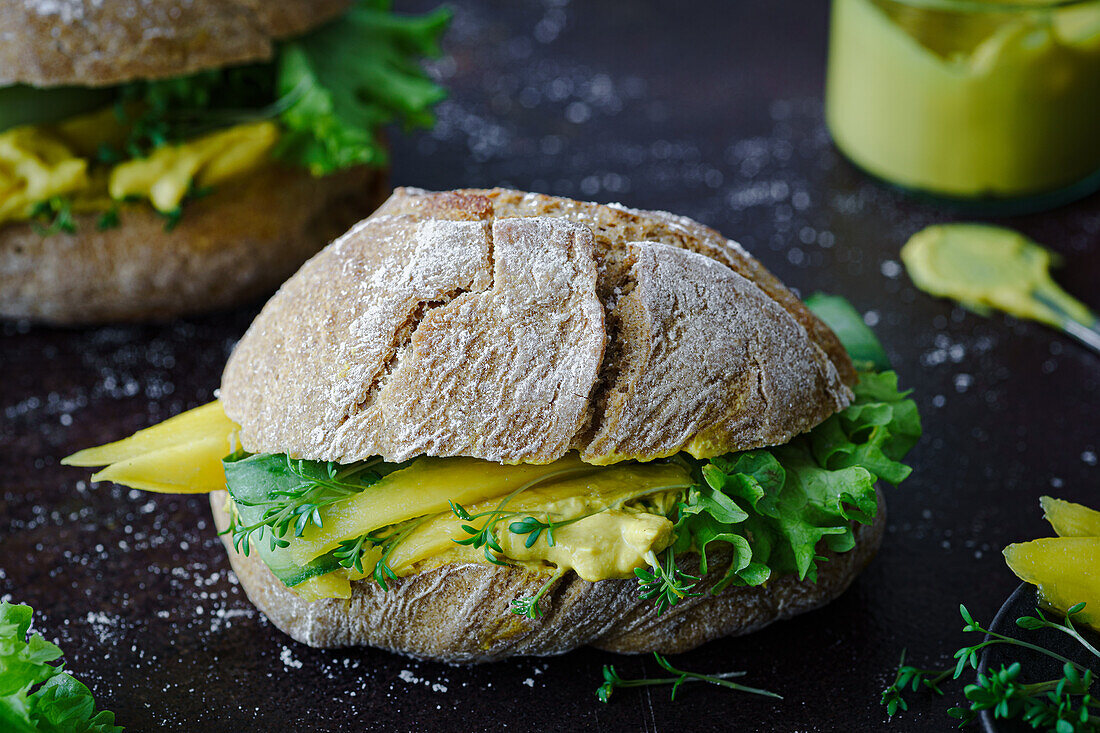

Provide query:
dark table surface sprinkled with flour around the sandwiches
left=0, top=0, right=1100, bottom=732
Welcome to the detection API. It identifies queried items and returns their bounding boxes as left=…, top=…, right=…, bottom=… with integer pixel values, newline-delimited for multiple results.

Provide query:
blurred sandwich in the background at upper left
left=0, top=0, right=449, bottom=324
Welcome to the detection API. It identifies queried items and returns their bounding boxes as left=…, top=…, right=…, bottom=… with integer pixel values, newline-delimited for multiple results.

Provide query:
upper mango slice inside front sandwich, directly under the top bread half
left=290, top=452, right=600, bottom=565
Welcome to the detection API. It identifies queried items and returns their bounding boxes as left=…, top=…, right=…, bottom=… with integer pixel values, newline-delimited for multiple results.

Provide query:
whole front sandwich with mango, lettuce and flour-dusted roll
left=65, top=188, right=921, bottom=663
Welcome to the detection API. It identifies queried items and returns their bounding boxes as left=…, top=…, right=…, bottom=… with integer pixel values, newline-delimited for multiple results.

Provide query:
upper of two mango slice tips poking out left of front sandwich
left=62, top=400, right=240, bottom=466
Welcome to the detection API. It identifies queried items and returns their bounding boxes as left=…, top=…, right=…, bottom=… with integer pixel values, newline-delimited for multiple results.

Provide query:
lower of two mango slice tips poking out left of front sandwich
left=91, top=438, right=232, bottom=494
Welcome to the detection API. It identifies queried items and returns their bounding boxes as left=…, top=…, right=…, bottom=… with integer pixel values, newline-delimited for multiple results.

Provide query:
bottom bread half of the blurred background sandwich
left=0, top=166, right=388, bottom=325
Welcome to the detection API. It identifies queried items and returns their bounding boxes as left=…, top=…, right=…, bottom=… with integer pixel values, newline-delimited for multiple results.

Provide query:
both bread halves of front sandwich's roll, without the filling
left=211, top=188, right=871, bottom=661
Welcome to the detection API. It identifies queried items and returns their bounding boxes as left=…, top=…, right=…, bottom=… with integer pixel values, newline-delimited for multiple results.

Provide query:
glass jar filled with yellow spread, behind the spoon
left=825, top=0, right=1100, bottom=210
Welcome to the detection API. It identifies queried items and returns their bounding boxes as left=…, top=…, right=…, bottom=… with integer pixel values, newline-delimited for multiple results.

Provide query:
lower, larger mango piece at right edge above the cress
left=1004, top=537, right=1100, bottom=630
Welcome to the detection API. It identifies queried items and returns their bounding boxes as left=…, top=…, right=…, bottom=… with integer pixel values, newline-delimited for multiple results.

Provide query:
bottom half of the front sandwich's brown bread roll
left=210, top=491, right=886, bottom=663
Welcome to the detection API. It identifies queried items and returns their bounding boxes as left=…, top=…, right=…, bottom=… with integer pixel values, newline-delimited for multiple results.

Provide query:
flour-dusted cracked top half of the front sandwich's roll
left=221, top=189, right=854, bottom=463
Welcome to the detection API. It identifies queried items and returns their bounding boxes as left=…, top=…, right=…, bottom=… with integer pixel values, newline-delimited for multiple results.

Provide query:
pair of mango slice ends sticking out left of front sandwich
left=62, top=401, right=240, bottom=494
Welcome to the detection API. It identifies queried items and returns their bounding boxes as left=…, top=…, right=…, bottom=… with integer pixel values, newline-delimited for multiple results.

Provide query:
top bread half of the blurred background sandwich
left=0, top=0, right=351, bottom=87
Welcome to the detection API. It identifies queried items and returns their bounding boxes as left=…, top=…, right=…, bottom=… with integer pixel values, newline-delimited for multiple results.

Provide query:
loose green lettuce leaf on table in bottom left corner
left=0, top=602, right=122, bottom=733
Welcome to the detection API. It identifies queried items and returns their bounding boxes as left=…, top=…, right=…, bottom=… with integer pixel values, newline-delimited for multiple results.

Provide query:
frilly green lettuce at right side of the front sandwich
left=675, top=365, right=921, bottom=592
